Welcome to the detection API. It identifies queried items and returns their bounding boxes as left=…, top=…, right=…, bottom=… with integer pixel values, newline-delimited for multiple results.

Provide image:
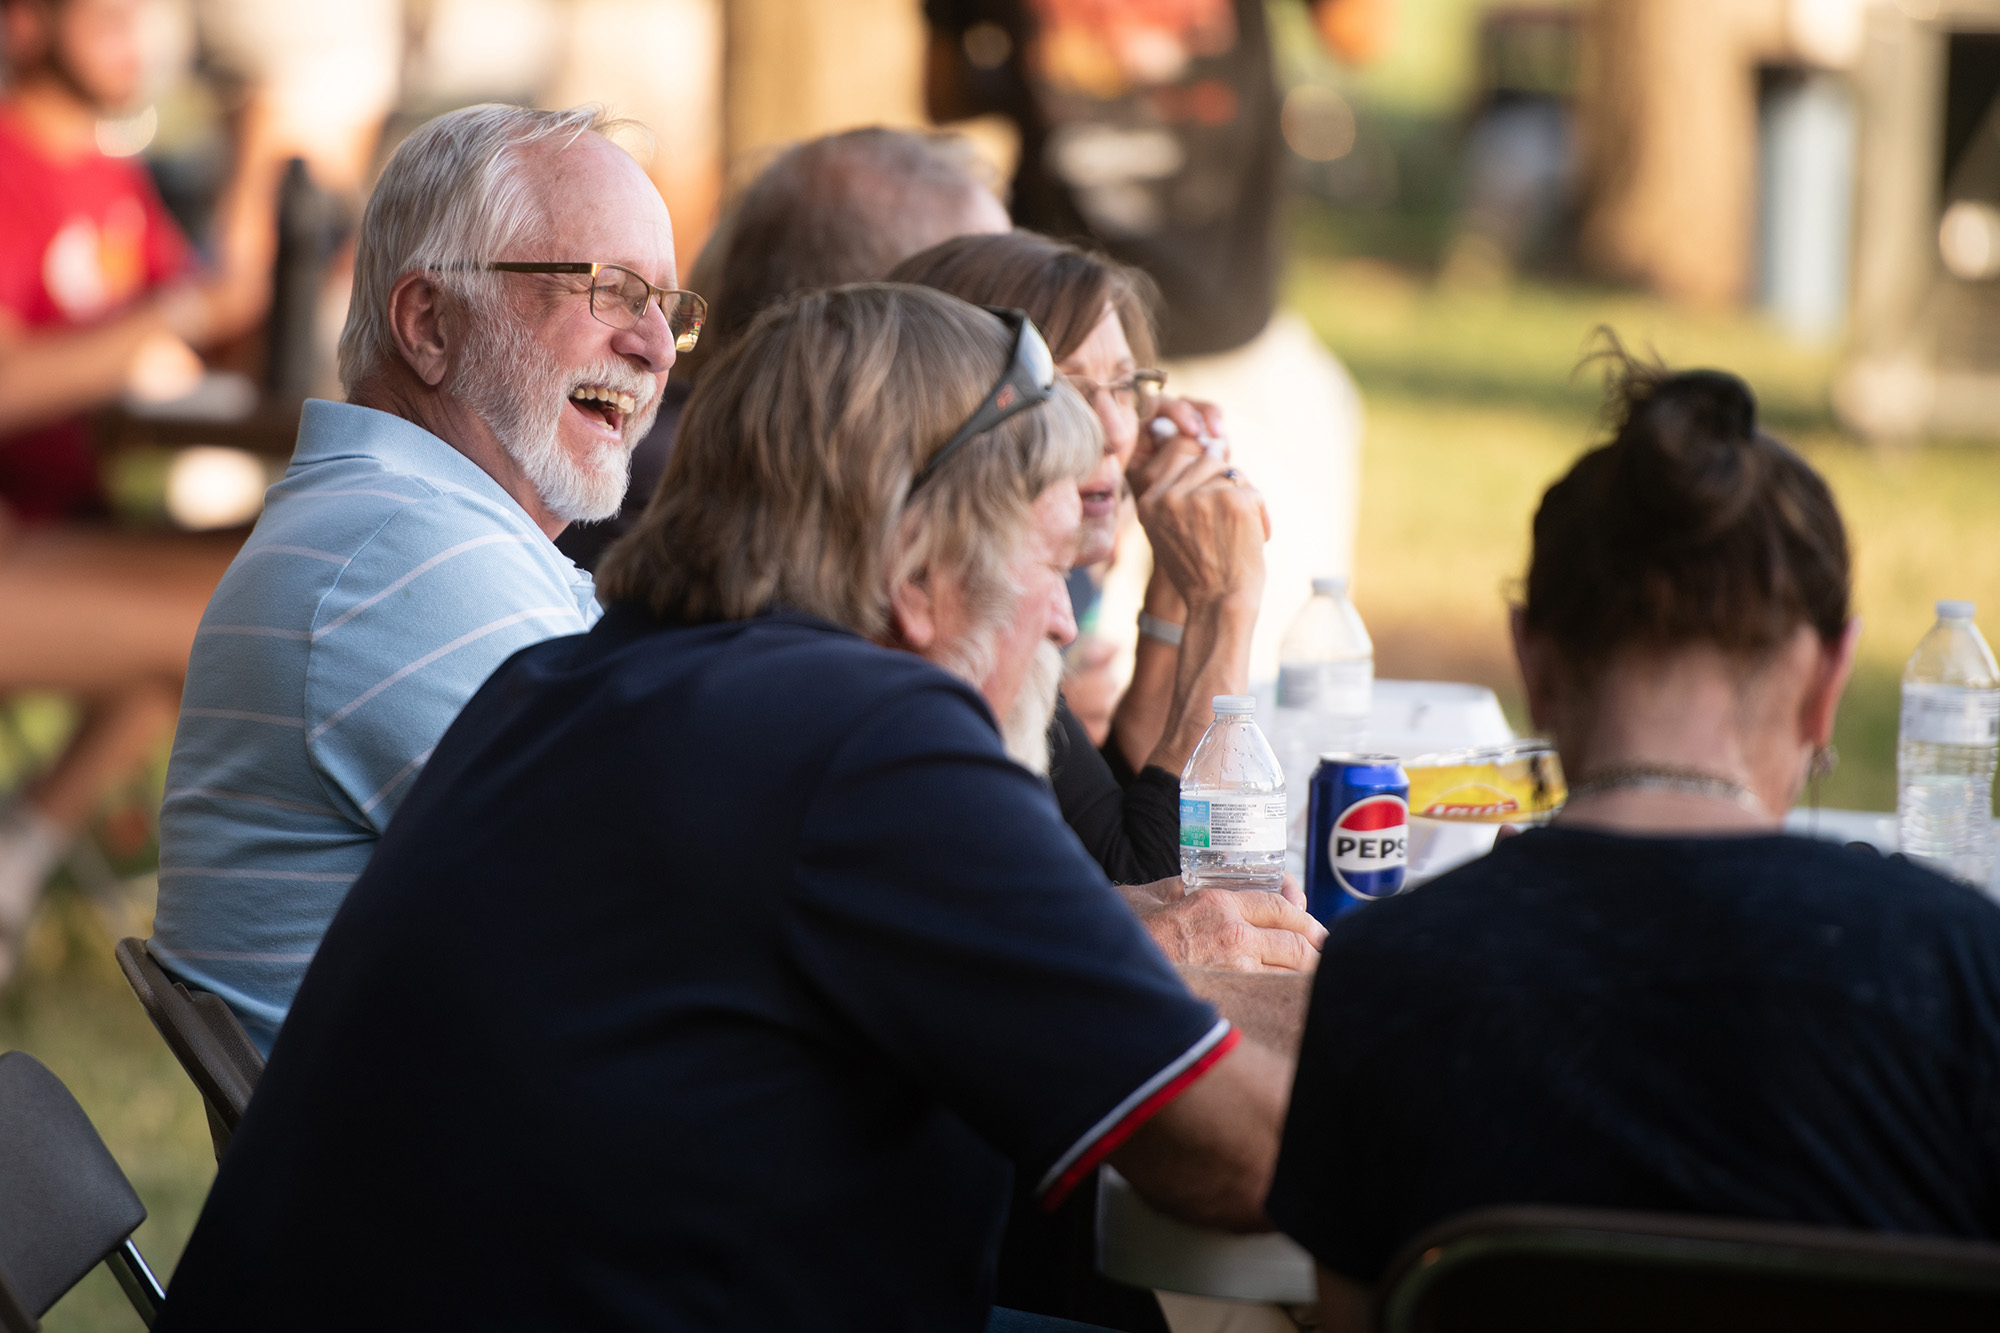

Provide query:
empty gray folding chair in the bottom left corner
left=0, top=1051, right=166, bottom=1333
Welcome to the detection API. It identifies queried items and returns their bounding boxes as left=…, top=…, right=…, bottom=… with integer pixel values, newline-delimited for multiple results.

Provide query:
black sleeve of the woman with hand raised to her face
left=1048, top=699, right=1180, bottom=885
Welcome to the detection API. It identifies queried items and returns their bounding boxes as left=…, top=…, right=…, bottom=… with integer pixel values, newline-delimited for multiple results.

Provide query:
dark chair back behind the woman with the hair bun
left=1376, top=1207, right=2000, bottom=1333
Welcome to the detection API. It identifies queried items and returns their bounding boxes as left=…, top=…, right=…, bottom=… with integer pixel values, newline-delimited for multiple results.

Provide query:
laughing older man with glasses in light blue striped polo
left=152, top=106, right=704, bottom=1049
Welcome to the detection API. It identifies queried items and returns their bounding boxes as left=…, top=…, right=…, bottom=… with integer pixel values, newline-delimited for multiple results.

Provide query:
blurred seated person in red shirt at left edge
left=0, top=0, right=278, bottom=964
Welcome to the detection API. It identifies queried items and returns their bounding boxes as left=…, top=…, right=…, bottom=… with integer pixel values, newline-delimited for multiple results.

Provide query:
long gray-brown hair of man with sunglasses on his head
left=598, top=284, right=1102, bottom=636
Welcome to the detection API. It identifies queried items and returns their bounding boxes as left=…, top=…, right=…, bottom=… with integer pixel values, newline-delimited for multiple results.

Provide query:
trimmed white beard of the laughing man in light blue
left=452, top=316, right=660, bottom=522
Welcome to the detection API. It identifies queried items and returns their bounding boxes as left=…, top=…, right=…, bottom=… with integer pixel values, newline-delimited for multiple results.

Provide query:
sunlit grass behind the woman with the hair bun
left=1290, top=239, right=2000, bottom=809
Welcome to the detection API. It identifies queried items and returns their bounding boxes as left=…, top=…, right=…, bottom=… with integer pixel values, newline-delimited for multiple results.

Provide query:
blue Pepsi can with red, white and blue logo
left=1306, top=755, right=1410, bottom=925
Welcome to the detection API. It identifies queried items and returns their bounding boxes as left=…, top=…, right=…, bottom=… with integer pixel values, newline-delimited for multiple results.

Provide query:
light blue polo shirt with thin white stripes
left=152, top=400, right=598, bottom=1051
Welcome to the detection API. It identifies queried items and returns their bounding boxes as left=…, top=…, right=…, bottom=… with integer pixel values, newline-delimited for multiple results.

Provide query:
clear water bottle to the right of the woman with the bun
left=1896, top=600, right=2000, bottom=889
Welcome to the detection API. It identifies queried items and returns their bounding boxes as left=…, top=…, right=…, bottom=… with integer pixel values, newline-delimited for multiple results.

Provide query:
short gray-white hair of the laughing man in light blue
left=340, top=102, right=620, bottom=394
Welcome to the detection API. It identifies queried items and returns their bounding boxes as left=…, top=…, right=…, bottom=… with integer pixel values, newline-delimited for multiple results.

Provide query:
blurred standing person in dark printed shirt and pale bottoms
left=924, top=0, right=1392, bottom=681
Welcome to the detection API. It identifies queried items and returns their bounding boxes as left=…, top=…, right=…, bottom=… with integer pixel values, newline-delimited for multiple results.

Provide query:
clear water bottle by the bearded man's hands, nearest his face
left=1180, top=695, right=1284, bottom=893
